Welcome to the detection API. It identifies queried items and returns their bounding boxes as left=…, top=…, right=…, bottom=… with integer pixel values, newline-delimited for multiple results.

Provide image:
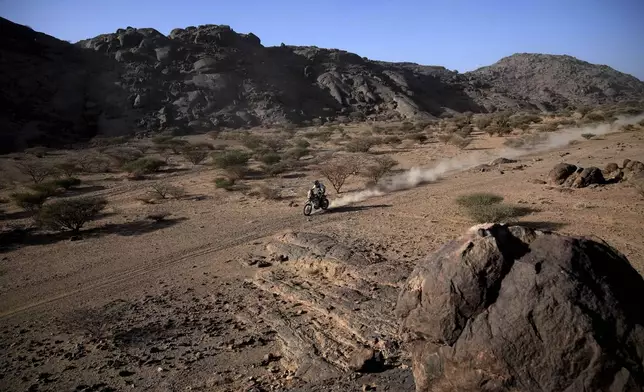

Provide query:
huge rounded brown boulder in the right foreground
left=396, top=225, right=644, bottom=392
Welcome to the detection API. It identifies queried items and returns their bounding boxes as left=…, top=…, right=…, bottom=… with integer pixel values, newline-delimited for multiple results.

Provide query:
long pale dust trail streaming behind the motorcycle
left=330, top=113, right=644, bottom=208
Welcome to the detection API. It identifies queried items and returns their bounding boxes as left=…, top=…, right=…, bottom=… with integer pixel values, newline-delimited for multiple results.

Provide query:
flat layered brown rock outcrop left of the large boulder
left=247, top=232, right=410, bottom=382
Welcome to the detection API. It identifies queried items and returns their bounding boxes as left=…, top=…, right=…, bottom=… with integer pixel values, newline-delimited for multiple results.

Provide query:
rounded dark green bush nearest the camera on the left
left=37, top=197, right=107, bottom=232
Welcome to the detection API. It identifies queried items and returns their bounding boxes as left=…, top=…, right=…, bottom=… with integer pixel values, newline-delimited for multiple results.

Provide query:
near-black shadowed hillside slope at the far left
left=0, top=18, right=128, bottom=153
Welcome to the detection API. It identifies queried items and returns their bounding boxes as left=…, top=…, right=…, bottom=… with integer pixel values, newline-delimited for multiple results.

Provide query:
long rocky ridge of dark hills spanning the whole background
left=0, top=18, right=644, bottom=151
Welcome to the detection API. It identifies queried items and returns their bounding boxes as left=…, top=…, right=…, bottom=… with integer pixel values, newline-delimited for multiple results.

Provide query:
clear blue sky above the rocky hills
left=0, top=0, right=644, bottom=80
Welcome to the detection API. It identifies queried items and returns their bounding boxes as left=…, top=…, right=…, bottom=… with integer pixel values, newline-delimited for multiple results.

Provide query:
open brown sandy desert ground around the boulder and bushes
left=0, top=115, right=644, bottom=391
